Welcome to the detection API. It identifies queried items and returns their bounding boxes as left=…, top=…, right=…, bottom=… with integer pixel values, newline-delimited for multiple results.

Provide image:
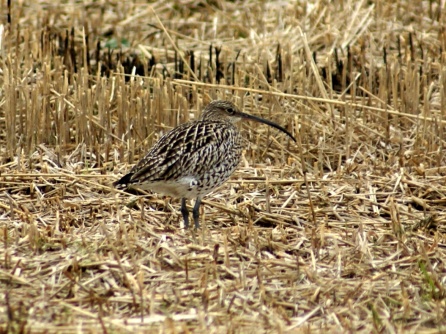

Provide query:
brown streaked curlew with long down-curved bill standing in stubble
left=113, top=100, right=296, bottom=229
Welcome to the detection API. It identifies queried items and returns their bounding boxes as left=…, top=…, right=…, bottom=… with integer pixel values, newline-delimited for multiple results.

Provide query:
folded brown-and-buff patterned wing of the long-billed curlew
left=129, top=121, right=237, bottom=183
